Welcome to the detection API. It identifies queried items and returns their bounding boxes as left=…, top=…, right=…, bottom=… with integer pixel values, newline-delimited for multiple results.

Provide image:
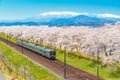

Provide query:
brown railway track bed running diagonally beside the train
left=0, top=37, right=104, bottom=80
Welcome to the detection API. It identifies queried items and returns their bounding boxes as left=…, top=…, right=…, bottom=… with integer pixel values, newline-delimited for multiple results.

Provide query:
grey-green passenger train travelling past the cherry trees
left=17, top=39, right=56, bottom=60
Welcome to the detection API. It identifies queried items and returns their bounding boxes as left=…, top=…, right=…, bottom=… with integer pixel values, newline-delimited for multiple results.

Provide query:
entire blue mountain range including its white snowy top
left=0, top=11, right=120, bottom=27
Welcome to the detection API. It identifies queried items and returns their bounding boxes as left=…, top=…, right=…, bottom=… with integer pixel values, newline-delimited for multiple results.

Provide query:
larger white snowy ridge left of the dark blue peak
left=40, top=11, right=88, bottom=17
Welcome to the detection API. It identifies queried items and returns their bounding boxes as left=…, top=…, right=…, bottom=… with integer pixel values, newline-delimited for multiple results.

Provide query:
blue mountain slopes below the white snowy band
left=0, top=15, right=120, bottom=27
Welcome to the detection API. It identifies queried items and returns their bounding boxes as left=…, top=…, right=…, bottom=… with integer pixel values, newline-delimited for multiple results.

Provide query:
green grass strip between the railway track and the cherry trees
left=0, top=32, right=120, bottom=80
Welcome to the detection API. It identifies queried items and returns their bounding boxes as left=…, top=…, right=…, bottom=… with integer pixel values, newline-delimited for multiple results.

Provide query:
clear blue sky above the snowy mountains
left=0, top=0, right=120, bottom=20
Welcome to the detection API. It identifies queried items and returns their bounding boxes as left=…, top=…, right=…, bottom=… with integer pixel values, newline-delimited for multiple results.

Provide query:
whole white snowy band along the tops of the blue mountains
left=40, top=11, right=120, bottom=18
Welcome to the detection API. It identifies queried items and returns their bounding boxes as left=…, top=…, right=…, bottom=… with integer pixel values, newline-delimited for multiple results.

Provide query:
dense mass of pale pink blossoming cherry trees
left=0, top=22, right=120, bottom=63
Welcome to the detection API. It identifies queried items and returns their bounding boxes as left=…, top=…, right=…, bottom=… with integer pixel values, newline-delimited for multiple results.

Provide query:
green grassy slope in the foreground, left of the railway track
left=0, top=42, right=60, bottom=80
